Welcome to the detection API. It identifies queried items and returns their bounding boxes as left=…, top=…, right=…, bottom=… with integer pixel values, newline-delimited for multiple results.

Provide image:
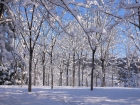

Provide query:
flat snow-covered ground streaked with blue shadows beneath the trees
left=0, top=86, right=140, bottom=105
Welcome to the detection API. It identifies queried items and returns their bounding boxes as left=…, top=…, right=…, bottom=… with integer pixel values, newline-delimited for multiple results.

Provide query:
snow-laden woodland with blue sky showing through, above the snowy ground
left=0, top=0, right=140, bottom=92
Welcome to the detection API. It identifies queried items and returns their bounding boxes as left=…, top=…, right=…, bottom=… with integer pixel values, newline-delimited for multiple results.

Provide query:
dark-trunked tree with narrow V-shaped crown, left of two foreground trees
left=17, top=5, right=44, bottom=92
